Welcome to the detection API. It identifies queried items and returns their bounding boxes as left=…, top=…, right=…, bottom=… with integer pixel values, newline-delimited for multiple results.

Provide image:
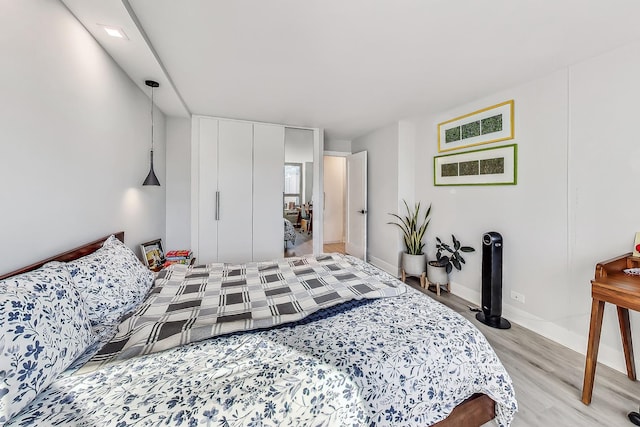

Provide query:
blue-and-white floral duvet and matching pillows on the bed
left=0, top=232, right=517, bottom=426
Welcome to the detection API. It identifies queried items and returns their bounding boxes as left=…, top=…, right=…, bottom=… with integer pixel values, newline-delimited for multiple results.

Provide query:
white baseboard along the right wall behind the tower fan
left=451, top=282, right=627, bottom=374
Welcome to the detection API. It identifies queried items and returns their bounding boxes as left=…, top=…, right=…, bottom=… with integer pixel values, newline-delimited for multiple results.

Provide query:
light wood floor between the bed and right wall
left=407, top=277, right=640, bottom=427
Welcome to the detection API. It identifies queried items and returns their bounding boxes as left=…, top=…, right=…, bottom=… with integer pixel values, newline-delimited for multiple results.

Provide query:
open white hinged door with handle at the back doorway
left=345, top=151, right=367, bottom=261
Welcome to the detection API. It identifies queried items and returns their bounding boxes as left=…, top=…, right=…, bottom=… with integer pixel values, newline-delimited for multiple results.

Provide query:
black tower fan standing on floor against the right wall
left=476, top=231, right=511, bottom=329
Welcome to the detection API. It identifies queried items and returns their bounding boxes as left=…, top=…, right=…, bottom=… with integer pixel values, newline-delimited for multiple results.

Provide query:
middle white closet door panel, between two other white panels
left=218, top=120, right=253, bottom=263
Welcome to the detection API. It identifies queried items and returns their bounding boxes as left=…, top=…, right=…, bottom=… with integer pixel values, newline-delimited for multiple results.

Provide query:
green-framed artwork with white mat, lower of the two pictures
left=433, top=144, right=518, bottom=186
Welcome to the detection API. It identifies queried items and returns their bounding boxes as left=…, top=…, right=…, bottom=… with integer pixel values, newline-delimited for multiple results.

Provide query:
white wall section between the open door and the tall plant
left=351, top=123, right=400, bottom=273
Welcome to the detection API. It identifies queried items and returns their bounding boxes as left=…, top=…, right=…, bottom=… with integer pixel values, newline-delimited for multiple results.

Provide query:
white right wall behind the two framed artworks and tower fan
left=409, top=43, right=640, bottom=370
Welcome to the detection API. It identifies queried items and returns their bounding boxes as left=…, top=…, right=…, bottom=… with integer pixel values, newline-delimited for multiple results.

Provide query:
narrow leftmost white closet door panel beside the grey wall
left=195, top=118, right=218, bottom=264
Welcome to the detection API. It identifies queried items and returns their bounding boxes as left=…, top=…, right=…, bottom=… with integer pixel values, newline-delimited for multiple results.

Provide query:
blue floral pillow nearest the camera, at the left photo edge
left=0, top=263, right=93, bottom=425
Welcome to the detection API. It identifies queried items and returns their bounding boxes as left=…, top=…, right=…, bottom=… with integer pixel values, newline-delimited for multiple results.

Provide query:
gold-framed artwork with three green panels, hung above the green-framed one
left=438, top=99, right=514, bottom=153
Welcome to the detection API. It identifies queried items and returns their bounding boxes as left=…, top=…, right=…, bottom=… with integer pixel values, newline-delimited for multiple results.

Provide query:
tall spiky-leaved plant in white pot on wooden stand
left=387, top=200, right=431, bottom=285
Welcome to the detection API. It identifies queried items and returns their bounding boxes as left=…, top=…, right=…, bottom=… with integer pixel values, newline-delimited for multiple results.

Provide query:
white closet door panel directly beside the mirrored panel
left=253, top=123, right=284, bottom=261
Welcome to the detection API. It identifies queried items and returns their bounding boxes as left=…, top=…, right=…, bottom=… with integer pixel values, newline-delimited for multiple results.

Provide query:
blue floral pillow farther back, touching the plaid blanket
left=67, top=236, right=153, bottom=325
